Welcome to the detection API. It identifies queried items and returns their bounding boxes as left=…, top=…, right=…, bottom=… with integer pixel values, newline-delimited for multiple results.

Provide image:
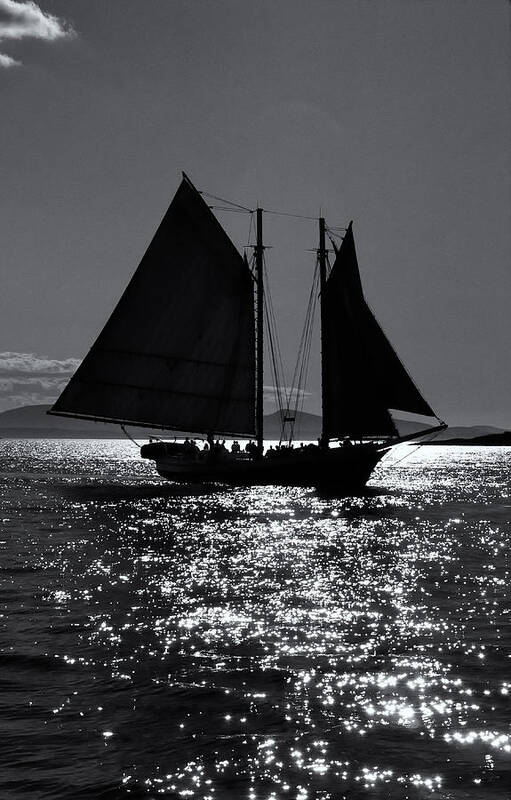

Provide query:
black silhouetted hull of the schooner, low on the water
left=141, top=442, right=388, bottom=493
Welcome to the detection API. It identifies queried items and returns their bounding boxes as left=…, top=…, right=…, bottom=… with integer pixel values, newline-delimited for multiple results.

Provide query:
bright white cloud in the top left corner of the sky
left=0, top=0, right=76, bottom=67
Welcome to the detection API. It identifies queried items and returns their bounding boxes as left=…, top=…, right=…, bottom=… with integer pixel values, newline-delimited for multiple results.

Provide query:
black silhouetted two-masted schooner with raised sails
left=48, top=174, right=446, bottom=493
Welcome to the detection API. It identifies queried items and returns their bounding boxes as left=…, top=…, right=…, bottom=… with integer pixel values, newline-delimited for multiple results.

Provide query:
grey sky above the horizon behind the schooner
left=0, top=0, right=511, bottom=427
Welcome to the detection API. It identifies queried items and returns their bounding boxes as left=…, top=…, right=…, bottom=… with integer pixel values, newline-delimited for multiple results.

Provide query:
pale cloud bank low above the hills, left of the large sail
left=0, top=352, right=80, bottom=411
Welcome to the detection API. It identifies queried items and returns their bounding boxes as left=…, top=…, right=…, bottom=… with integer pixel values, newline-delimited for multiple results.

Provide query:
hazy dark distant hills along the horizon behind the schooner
left=0, top=405, right=504, bottom=443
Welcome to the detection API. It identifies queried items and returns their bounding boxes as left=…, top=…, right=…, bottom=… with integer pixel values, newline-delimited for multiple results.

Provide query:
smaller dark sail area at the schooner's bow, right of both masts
left=323, top=223, right=434, bottom=438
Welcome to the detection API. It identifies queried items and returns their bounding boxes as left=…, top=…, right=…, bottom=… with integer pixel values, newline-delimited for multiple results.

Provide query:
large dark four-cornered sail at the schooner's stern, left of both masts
left=50, top=178, right=255, bottom=435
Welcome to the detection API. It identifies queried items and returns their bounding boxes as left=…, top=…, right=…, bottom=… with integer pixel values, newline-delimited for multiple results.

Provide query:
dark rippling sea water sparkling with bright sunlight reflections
left=0, top=440, right=511, bottom=800
